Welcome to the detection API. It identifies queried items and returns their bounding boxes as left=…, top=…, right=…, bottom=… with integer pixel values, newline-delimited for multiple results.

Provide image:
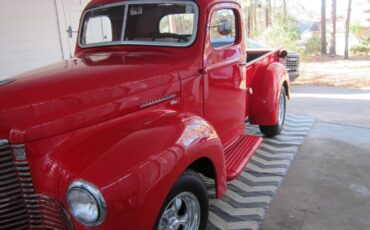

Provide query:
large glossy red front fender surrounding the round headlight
left=27, top=110, right=226, bottom=229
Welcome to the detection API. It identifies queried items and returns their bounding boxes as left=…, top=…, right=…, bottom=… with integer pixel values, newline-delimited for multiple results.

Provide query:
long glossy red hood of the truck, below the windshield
left=0, top=52, right=183, bottom=144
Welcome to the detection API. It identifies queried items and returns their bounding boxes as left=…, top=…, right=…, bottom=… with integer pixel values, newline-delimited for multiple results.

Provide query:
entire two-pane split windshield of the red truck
left=79, top=1, right=198, bottom=47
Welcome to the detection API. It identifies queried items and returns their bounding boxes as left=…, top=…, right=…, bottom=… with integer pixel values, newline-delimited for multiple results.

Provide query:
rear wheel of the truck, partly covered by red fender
left=260, top=87, right=286, bottom=137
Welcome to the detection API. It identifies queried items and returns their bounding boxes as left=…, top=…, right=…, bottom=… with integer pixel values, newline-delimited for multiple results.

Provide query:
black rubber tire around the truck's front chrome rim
left=154, top=170, right=209, bottom=230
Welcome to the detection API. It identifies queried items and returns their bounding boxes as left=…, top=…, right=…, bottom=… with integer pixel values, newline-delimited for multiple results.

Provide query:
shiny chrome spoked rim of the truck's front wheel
left=158, top=192, right=201, bottom=230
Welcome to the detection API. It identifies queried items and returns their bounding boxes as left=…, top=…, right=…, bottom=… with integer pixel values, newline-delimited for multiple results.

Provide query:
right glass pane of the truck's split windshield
left=124, top=3, right=197, bottom=45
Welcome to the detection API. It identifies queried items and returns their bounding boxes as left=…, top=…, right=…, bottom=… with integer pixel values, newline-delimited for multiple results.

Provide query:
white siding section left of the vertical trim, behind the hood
left=0, top=0, right=62, bottom=79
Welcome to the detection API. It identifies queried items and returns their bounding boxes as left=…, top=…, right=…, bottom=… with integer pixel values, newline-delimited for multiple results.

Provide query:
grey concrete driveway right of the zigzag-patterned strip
left=261, top=86, right=370, bottom=230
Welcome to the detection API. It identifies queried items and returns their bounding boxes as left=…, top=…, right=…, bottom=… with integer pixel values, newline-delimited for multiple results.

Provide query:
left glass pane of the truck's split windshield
left=80, top=6, right=125, bottom=45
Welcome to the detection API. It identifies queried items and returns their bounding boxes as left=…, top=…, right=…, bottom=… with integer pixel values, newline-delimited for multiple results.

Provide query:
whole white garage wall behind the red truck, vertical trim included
left=0, top=0, right=88, bottom=80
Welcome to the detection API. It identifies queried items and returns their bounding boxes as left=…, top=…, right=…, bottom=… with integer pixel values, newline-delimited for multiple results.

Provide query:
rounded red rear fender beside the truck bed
left=249, top=62, right=289, bottom=125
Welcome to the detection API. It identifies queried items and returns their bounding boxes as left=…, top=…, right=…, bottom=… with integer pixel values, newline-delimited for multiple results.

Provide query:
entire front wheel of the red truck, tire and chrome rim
left=154, top=170, right=208, bottom=230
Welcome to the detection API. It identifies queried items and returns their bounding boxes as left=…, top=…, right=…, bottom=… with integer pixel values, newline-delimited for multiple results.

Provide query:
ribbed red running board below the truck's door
left=225, top=135, right=262, bottom=181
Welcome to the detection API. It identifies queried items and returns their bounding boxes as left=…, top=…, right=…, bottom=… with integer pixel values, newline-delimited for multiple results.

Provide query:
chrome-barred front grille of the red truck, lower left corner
left=0, top=140, right=74, bottom=230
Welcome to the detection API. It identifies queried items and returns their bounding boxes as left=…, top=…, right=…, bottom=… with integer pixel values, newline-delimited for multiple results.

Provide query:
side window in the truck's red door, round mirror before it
left=210, top=9, right=237, bottom=48
